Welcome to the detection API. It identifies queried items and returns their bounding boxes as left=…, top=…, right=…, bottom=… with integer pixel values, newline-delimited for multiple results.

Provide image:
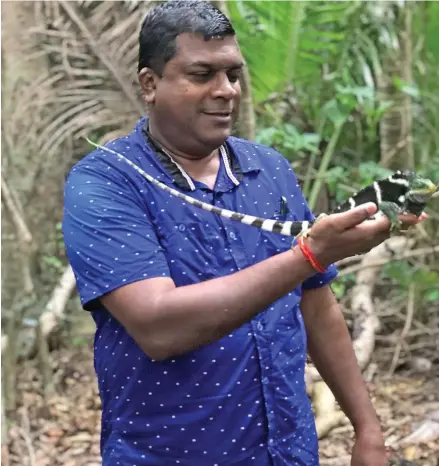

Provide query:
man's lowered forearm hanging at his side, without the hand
left=301, top=287, right=379, bottom=433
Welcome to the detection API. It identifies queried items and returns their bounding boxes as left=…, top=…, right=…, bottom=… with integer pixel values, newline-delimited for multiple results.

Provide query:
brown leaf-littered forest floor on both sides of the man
left=2, top=338, right=439, bottom=466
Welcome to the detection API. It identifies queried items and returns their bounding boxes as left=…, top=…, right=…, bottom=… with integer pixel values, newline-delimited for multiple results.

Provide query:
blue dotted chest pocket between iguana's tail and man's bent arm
left=156, top=215, right=224, bottom=286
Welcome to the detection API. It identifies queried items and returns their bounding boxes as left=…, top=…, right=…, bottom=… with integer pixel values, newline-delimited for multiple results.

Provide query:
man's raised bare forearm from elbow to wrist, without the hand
left=109, top=248, right=315, bottom=359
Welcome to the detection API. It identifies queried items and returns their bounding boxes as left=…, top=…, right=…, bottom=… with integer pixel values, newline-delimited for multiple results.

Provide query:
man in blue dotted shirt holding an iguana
left=63, top=2, right=424, bottom=466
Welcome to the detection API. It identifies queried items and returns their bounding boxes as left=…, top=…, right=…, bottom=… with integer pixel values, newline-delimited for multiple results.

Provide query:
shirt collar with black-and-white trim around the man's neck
left=141, top=118, right=260, bottom=191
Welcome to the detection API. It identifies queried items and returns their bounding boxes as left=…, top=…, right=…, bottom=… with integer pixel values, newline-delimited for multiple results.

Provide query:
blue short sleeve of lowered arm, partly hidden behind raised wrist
left=281, top=156, right=338, bottom=290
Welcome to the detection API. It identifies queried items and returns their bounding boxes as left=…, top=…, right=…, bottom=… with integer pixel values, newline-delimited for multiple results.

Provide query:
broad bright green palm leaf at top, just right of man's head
left=228, top=0, right=357, bottom=103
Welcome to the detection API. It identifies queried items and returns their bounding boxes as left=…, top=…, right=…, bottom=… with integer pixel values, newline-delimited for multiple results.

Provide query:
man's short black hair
left=137, top=0, right=235, bottom=76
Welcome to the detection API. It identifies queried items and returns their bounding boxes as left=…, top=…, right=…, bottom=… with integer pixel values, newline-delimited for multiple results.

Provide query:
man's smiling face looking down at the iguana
left=140, top=33, right=243, bottom=155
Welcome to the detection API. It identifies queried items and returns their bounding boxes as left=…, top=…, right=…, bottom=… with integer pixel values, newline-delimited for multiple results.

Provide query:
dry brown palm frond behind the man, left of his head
left=9, top=1, right=155, bottom=167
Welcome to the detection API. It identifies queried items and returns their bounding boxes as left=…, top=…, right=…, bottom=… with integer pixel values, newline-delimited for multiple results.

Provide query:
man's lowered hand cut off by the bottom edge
left=351, top=431, right=388, bottom=466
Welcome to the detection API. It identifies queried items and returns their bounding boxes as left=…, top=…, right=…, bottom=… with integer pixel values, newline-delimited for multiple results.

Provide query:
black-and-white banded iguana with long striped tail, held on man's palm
left=86, top=138, right=438, bottom=237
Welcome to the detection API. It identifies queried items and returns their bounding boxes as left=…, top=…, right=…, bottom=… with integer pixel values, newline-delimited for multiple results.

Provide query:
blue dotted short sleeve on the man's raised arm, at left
left=62, top=157, right=170, bottom=309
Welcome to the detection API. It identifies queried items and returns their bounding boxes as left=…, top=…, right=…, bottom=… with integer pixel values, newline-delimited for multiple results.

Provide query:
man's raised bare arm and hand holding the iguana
left=101, top=205, right=398, bottom=359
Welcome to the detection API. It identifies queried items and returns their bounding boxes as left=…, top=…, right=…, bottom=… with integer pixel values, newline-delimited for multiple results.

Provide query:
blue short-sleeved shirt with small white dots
left=63, top=118, right=337, bottom=466
